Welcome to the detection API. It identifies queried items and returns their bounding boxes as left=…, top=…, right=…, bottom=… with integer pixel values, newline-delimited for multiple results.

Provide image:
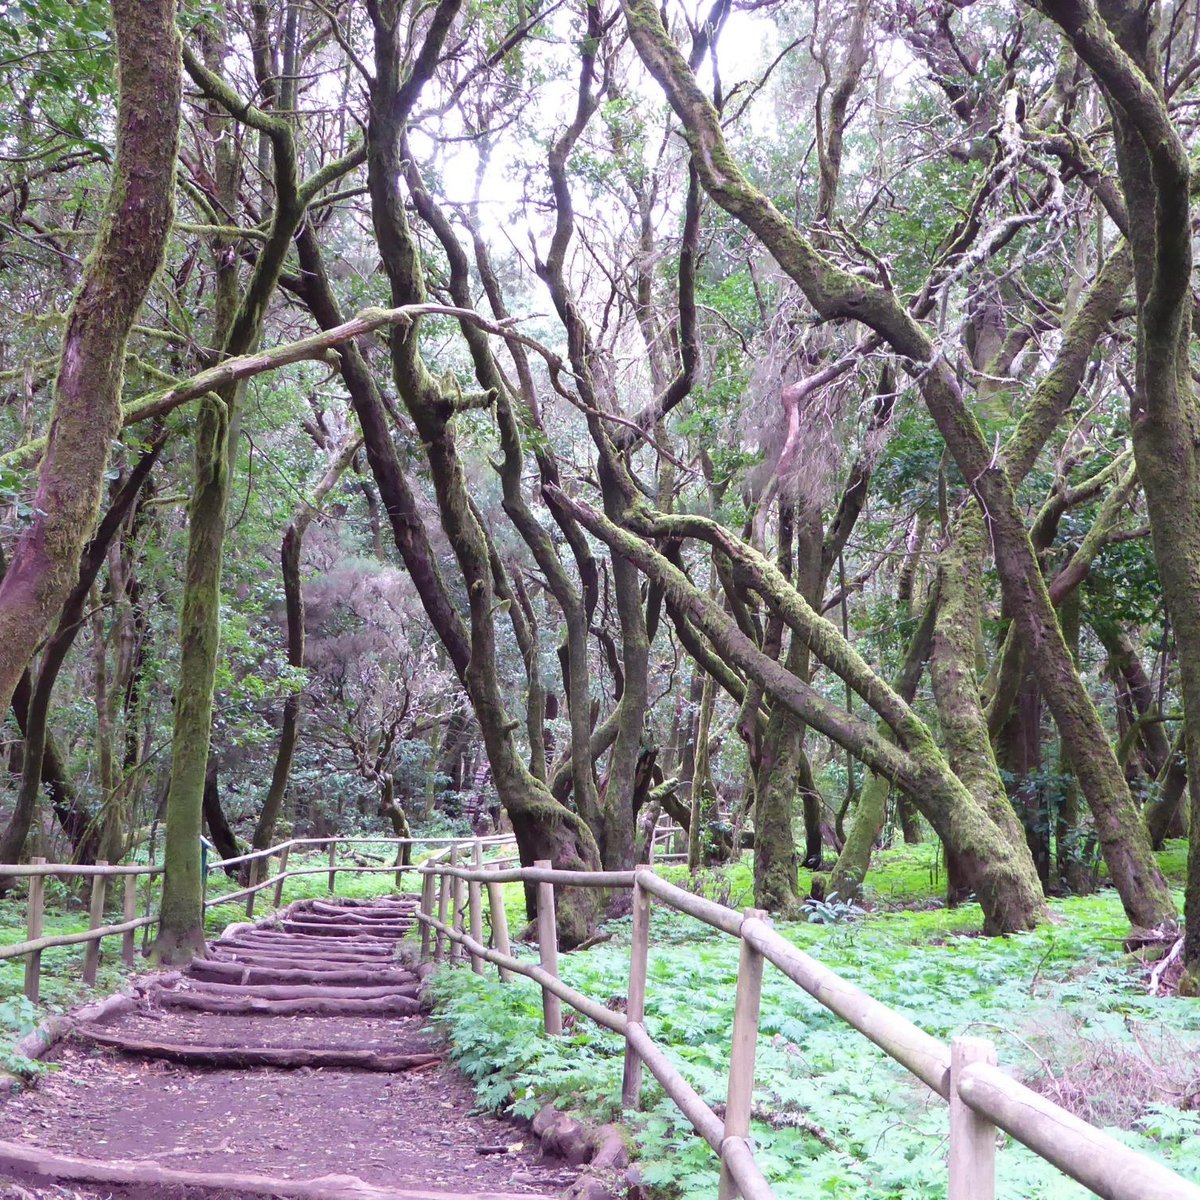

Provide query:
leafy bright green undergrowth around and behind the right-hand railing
left=433, top=846, right=1200, bottom=1200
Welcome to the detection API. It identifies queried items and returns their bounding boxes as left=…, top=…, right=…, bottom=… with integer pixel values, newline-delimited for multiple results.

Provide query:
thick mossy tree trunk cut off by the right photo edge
left=1043, top=0, right=1200, bottom=955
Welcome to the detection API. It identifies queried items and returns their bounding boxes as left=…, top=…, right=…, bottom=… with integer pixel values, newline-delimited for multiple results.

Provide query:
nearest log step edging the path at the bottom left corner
left=0, top=1141, right=554, bottom=1200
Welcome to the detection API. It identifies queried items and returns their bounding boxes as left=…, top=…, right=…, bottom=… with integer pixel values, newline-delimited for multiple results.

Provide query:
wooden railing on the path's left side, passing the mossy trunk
left=0, top=834, right=514, bottom=1003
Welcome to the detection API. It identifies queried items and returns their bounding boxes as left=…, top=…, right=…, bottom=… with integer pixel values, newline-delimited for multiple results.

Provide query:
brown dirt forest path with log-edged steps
left=0, top=895, right=576, bottom=1200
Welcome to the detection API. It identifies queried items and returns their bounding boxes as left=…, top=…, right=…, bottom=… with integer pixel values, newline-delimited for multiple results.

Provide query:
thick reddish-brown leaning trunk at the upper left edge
left=0, top=0, right=182, bottom=720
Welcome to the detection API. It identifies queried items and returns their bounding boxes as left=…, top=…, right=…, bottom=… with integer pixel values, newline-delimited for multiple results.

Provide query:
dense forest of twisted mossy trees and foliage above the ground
left=0, top=0, right=1200, bottom=982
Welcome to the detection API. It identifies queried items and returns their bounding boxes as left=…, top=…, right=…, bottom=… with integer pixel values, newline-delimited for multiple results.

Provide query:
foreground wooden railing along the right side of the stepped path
left=419, top=862, right=1200, bottom=1200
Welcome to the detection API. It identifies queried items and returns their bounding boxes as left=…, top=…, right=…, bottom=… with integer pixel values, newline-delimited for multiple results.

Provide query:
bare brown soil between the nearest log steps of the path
left=0, top=897, right=577, bottom=1200
